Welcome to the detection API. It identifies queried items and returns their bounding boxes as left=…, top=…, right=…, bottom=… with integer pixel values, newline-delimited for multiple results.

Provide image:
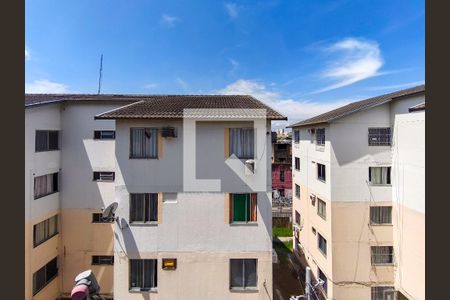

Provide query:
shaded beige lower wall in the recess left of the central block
left=61, top=208, right=114, bottom=294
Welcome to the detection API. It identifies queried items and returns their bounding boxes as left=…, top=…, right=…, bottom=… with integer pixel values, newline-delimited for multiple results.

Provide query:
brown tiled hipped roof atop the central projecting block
left=96, top=95, right=287, bottom=120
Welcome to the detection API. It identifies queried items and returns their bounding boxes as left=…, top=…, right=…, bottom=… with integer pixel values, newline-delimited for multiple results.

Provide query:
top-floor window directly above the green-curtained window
left=230, top=128, right=255, bottom=158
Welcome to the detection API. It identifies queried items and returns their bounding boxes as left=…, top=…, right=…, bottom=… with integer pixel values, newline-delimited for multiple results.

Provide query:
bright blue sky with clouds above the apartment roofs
left=25, top=0, right=425, bottom=125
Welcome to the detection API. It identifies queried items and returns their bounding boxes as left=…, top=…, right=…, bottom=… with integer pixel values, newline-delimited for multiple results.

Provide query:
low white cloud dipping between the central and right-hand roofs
left=216, top=79, right=350, bottom=127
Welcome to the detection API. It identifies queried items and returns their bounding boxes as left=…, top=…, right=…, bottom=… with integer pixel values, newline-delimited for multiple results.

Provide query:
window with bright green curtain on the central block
left=231, top=193, right=257, bottom=222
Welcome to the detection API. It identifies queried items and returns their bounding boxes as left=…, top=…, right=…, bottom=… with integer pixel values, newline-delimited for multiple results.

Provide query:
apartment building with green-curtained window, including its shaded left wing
left=25, top=95, right=286, bottom=299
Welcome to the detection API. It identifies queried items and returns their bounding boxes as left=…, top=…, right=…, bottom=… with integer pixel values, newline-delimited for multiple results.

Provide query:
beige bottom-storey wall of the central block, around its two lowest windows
left=114, top=252, right=272, bottom=300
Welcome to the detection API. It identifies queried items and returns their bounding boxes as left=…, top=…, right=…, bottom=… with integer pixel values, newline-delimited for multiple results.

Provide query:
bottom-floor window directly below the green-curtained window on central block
left=230, top=259, right=258, bottom=289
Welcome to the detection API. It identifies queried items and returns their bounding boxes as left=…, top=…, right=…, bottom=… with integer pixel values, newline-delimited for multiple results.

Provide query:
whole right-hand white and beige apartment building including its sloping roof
left=290, top=85, right=425, bottom=300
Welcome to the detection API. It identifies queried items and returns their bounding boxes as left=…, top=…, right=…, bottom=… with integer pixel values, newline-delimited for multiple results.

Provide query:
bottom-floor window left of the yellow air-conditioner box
left=130, top=259, right=158, bottom=291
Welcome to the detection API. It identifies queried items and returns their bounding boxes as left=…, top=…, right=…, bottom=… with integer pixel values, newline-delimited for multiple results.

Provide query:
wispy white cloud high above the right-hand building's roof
left=311, top=38, right=383, bottom=94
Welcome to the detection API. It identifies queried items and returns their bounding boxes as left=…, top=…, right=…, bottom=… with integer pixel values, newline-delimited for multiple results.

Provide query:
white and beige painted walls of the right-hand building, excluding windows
left=292, top=93, right=425, bottom=300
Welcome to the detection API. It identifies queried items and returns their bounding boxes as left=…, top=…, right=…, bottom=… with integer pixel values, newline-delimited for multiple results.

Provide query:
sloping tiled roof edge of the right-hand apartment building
left=288, top=84, right=425, bottom=128
